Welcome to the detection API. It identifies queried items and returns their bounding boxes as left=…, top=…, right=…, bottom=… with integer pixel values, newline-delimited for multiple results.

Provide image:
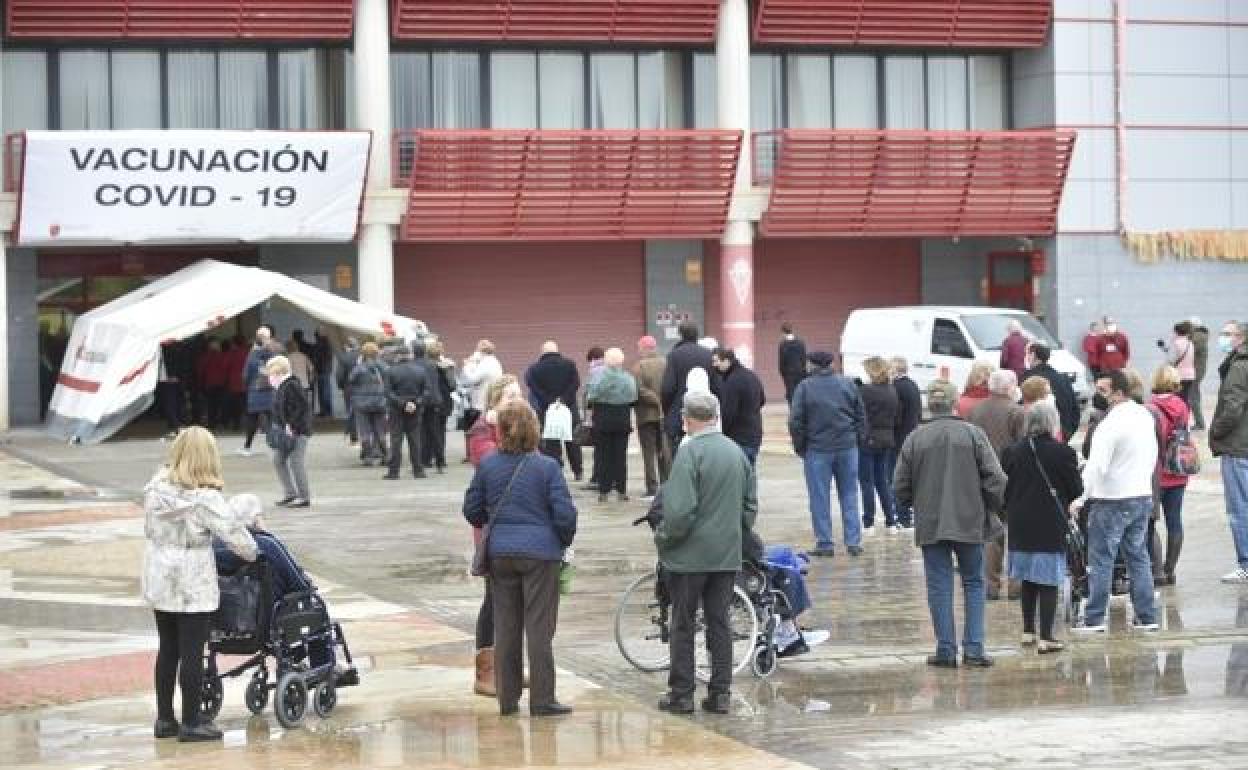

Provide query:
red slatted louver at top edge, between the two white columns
left=391, top=0, right=719, bottom=44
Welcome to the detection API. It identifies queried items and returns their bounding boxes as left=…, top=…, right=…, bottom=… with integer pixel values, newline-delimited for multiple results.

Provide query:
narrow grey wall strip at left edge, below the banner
left=5, top=248, right=40, bottom=427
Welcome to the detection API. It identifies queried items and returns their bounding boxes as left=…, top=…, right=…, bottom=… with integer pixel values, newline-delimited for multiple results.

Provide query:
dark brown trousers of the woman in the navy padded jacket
left=489, top=557, right=559, bottom=709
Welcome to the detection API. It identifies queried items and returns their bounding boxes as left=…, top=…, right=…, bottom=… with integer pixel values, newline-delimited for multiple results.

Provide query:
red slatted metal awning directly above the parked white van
left=755, top=130, right=1075, bottom=237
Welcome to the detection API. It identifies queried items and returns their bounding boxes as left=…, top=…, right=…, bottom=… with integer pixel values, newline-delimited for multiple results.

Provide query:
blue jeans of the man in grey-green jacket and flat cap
left=924, top=540, right=983, bottom=660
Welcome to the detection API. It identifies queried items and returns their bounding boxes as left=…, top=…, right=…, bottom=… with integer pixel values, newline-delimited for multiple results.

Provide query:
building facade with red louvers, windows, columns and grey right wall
left=0, top=0, right=1248, bottom=424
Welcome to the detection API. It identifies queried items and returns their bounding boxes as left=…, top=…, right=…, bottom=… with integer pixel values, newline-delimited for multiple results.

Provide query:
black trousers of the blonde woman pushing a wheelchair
left=155, top=610, right=212, bottom=728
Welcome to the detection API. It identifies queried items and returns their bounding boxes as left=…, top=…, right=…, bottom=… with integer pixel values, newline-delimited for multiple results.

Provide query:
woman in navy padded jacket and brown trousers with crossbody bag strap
left=463, top=402, right=577, bottom=716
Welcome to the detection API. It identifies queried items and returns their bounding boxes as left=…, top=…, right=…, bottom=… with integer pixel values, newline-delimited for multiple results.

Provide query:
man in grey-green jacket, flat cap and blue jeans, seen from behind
left=894, top=379, right=1006, bottom=669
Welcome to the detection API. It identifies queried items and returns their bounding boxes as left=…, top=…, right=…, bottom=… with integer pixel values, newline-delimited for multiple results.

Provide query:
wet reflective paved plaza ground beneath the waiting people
left=0, top=414, right=1248, bottom=768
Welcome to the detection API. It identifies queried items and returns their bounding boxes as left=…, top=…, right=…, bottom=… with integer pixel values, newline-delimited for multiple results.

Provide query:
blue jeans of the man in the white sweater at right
left=1085, top=497, right=1157, bottom=625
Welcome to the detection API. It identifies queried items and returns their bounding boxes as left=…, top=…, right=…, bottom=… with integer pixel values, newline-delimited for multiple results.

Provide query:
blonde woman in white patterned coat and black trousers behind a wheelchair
left=140, top=427, right=256, bottom=741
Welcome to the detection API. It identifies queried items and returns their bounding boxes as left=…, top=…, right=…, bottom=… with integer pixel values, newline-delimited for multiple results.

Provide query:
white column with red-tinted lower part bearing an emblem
left=715, top=0, right=756, bottom=368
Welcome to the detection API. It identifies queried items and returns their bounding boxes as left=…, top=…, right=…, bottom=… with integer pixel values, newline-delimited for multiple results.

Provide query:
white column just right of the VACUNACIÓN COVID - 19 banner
left=354, top=0, right=394, bottom=311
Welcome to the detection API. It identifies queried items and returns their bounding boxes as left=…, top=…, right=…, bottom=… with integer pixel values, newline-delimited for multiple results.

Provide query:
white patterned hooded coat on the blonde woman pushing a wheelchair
left=140, top=468, right=256, bottom=613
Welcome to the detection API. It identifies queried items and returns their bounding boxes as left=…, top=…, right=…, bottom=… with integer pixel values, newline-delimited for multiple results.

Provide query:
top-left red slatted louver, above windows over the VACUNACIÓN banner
left=6, top=0, right=352, bottom=40
